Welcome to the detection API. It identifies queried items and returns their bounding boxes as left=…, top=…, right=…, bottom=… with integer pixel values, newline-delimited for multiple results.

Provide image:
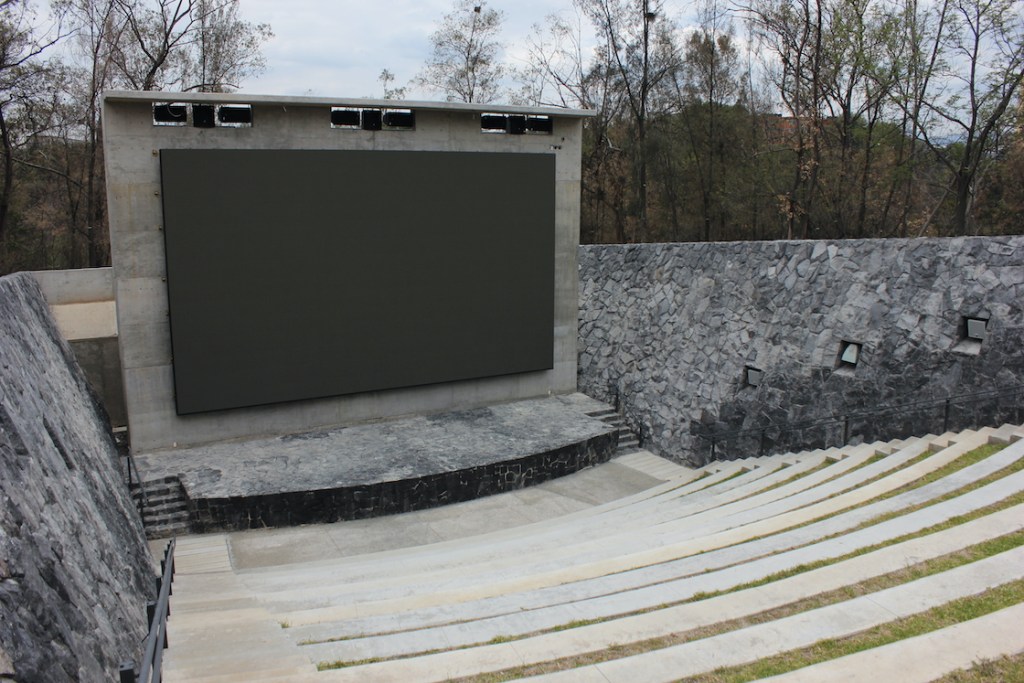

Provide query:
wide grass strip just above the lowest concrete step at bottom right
left=680, top=580, right=1024, bottom=683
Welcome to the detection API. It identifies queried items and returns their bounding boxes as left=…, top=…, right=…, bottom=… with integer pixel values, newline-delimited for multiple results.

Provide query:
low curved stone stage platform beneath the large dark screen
left=135, top=393, right=617, bottom=532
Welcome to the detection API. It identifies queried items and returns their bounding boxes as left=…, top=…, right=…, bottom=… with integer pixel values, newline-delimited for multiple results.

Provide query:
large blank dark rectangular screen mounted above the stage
left=160, top=150, right=555, bottom=415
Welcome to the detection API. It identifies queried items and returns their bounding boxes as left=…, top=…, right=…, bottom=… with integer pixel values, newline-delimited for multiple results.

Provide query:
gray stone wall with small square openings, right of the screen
left=579, top=237, right=1024, bottom=463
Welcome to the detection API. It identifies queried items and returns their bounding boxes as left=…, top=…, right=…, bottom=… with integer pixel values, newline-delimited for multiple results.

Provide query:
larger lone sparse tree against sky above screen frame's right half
left=415, top=0, right=505, bottom=102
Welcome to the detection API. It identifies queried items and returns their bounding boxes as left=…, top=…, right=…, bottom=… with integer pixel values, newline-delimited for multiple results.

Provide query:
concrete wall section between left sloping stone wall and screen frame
left=32, top=268, right=128, bottom=427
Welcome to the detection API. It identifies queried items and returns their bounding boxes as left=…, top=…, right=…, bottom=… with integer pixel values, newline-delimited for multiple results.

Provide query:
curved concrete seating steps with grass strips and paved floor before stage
left=157, top=426, right=1024, bottom=681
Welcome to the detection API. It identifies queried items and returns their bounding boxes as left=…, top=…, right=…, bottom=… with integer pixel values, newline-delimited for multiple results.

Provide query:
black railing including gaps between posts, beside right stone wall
left=694, top=384, right=1024, bottom=463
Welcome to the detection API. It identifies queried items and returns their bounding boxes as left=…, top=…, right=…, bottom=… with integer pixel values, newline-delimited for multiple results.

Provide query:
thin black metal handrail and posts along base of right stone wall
left=693, top=384, right=1024, bottom=462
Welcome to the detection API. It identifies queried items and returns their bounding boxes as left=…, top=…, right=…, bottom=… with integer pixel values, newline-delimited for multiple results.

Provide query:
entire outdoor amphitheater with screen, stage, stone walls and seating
left=0, top=93, right=1024, bottom=683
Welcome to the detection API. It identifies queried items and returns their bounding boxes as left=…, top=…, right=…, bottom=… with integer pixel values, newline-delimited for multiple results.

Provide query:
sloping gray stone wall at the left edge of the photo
left=0, top=273, right=154, bottom=682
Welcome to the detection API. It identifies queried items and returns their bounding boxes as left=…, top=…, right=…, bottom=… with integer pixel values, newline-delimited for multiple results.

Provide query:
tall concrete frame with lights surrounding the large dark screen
left=103, top=92, right=593, bottom=452
